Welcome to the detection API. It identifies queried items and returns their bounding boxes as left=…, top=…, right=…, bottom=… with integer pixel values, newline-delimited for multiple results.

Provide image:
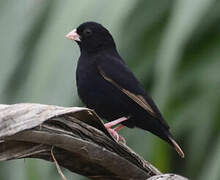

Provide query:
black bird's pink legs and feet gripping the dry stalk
left=105, top=117, right=128, bottom=142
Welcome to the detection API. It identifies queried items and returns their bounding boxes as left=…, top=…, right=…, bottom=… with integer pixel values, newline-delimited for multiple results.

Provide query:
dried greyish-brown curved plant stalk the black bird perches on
left=0, top=104, right=187, bottom=180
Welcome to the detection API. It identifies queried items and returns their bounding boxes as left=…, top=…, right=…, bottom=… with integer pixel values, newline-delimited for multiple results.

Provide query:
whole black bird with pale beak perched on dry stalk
left=66, top=22, right=184, bottom=157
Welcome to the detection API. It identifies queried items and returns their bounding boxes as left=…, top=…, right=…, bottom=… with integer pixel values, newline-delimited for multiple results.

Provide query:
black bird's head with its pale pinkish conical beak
left=66, top=22, right=115, bottom=52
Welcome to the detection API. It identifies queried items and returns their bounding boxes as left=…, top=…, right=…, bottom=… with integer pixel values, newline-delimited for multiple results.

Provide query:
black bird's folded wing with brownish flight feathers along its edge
left=97, top=54, right=167, bottom=121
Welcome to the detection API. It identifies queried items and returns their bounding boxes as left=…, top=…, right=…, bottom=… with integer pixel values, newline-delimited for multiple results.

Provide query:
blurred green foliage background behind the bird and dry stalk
left=0, top=0, right=220, bottom=180
